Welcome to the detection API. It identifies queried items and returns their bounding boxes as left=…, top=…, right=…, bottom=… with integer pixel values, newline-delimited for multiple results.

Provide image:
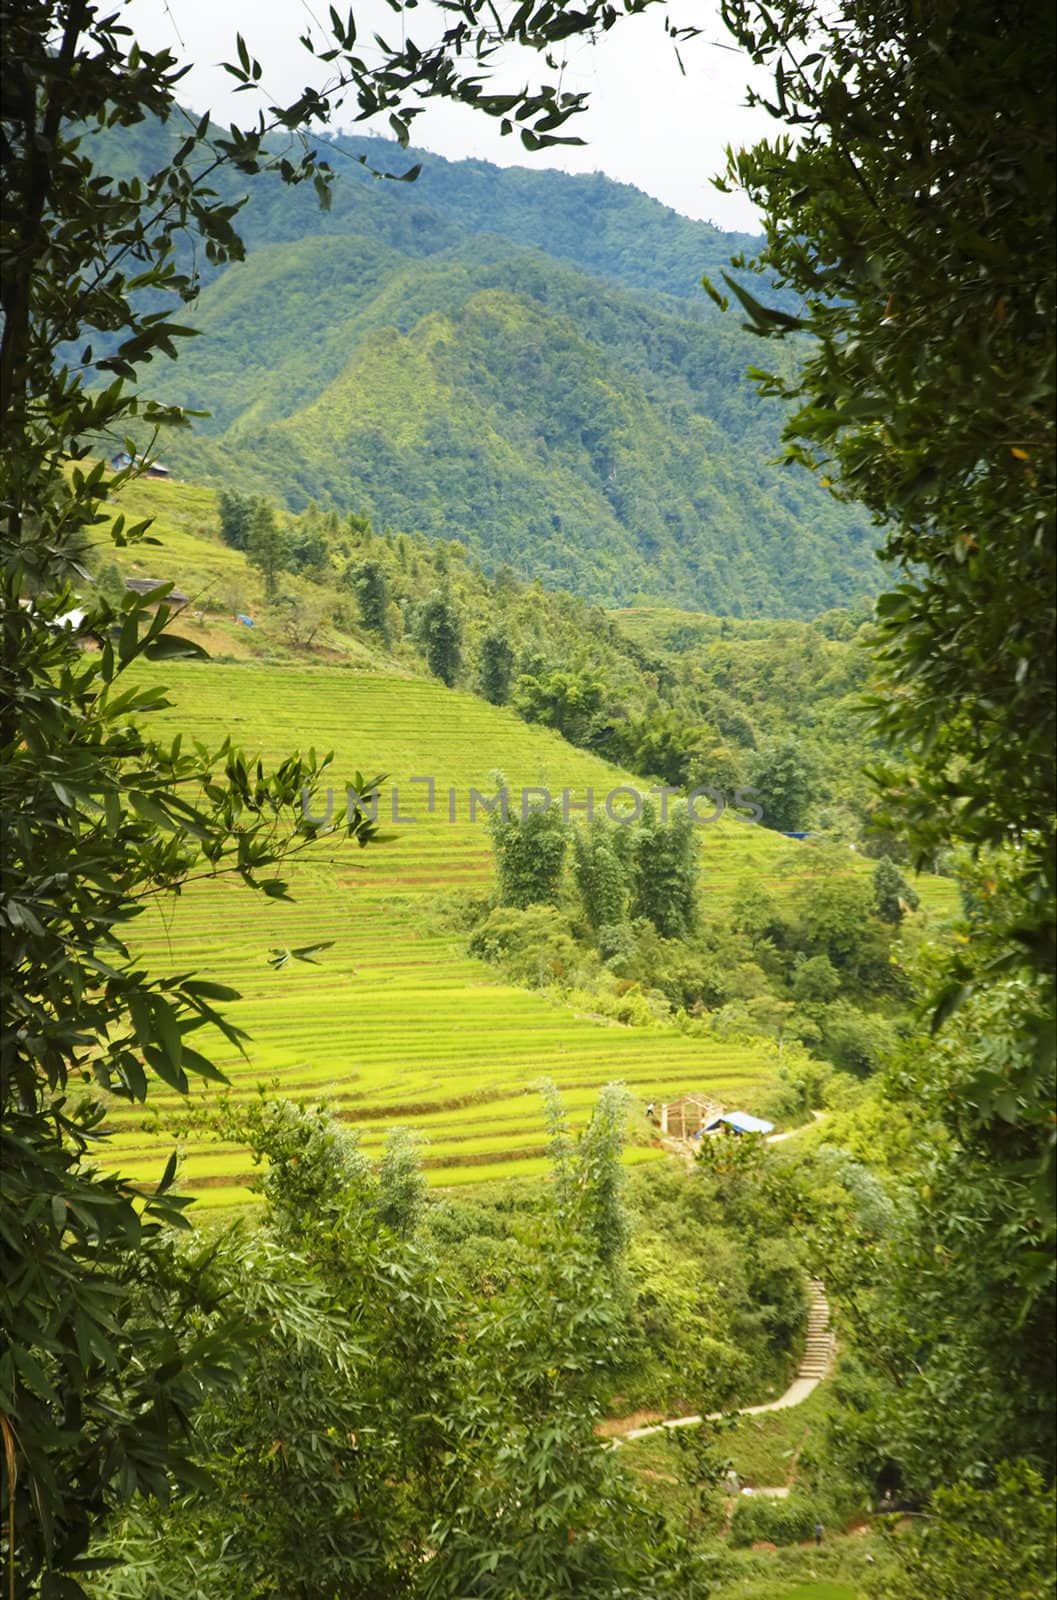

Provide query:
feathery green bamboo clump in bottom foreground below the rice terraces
left=90, top=1085, right=707, bottom=1600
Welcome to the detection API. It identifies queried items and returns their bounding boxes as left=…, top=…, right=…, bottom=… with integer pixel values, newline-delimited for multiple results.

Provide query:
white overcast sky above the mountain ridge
left=125, top=0, right=776, bottom=230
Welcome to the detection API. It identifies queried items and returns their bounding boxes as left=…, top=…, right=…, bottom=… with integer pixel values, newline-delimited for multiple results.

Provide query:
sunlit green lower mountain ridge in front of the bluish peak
left=165, top=238, right=876, bottom=616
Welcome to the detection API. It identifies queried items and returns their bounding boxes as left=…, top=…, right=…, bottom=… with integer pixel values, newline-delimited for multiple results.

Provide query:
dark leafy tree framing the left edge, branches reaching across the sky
left=0, top=0, right=609, bottom=1574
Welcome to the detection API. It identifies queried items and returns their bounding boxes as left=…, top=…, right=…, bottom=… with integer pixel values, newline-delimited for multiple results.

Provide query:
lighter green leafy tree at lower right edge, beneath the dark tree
left=860, top=979, right=1057, bottom=1494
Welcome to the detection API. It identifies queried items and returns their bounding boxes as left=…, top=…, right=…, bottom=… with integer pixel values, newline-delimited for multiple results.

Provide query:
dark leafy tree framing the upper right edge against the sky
left=723, top=0, right=1057, bottom=1100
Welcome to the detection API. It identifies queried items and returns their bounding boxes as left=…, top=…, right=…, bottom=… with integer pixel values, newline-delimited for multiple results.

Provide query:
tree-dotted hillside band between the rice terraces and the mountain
left=101, top=470, right=905, bottom=858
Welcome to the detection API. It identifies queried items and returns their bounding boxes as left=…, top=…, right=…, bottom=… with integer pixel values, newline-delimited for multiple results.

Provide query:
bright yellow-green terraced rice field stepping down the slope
left=101, top=662, right=959, bottom=1205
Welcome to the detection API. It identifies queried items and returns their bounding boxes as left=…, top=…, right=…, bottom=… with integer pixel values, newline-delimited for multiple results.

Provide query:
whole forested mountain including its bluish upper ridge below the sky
left=104, top=116, right=876, bottom=616
